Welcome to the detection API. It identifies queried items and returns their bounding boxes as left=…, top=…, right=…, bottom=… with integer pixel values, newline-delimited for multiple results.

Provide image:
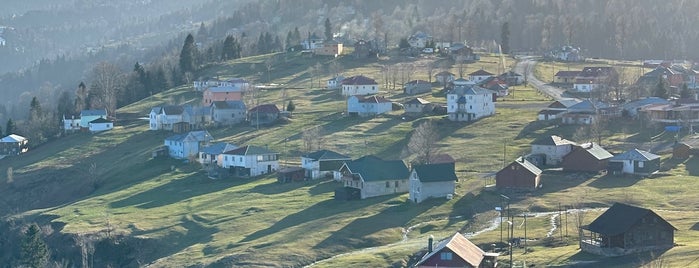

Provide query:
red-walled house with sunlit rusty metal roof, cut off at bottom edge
left=414, top=233, right=499, bottom=268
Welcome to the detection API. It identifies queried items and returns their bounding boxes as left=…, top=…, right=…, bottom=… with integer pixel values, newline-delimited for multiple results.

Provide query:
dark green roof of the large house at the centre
left=343, top=155, right=410, bottom=181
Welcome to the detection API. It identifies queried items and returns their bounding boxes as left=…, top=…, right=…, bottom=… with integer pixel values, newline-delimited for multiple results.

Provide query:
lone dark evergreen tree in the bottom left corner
left=20, top=224, right=49, bottom=268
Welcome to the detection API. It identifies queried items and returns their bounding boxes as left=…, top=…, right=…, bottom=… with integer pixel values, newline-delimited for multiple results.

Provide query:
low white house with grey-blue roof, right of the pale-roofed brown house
left=607, top=149, right=660, bottom=176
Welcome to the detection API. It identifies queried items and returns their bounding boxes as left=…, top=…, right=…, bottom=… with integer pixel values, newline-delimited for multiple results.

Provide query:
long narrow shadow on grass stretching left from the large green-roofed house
left=239, top=196, right=392, bottom=243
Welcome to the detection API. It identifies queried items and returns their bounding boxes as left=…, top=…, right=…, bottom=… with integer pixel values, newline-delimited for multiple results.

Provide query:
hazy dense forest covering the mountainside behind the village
left=0, top=0, right=699, bottom=143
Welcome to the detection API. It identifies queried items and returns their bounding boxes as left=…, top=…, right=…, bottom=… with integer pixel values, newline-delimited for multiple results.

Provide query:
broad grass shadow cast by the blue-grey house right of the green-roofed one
left=313, top=198, right=434, bottom=251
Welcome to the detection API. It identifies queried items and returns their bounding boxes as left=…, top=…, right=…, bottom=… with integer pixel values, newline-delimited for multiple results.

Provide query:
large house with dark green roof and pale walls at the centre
left=335, top=155, right=409, bottom=200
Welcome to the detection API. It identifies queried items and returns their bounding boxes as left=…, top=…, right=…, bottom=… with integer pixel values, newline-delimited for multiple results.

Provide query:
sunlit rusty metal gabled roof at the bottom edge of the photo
left=415, top=233, right=485, bottom=267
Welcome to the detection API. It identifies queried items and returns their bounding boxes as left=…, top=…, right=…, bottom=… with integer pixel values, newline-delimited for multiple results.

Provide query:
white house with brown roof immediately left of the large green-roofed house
left=301, top=150, right=352, bottom=180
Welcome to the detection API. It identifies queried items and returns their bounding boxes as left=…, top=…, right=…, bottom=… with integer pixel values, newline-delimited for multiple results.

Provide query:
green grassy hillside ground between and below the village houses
left=0, top=51, right=699, bottom=267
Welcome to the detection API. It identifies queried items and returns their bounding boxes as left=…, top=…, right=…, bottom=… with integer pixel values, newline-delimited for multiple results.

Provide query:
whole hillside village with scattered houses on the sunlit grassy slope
left=0, top=27, right=699, bottom=267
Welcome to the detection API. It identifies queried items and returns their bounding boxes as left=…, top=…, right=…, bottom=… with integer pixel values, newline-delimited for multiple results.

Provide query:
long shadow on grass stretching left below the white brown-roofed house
left=109, top=173, right=235, bottom=209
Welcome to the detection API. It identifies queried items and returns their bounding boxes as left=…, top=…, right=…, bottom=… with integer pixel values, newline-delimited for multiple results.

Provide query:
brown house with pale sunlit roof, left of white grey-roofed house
left=561, top=142, right=612, bottom=172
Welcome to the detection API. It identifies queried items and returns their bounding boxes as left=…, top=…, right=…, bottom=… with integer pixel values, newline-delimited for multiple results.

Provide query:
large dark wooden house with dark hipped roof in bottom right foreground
left=580, top=203, right=677, bottom=256
